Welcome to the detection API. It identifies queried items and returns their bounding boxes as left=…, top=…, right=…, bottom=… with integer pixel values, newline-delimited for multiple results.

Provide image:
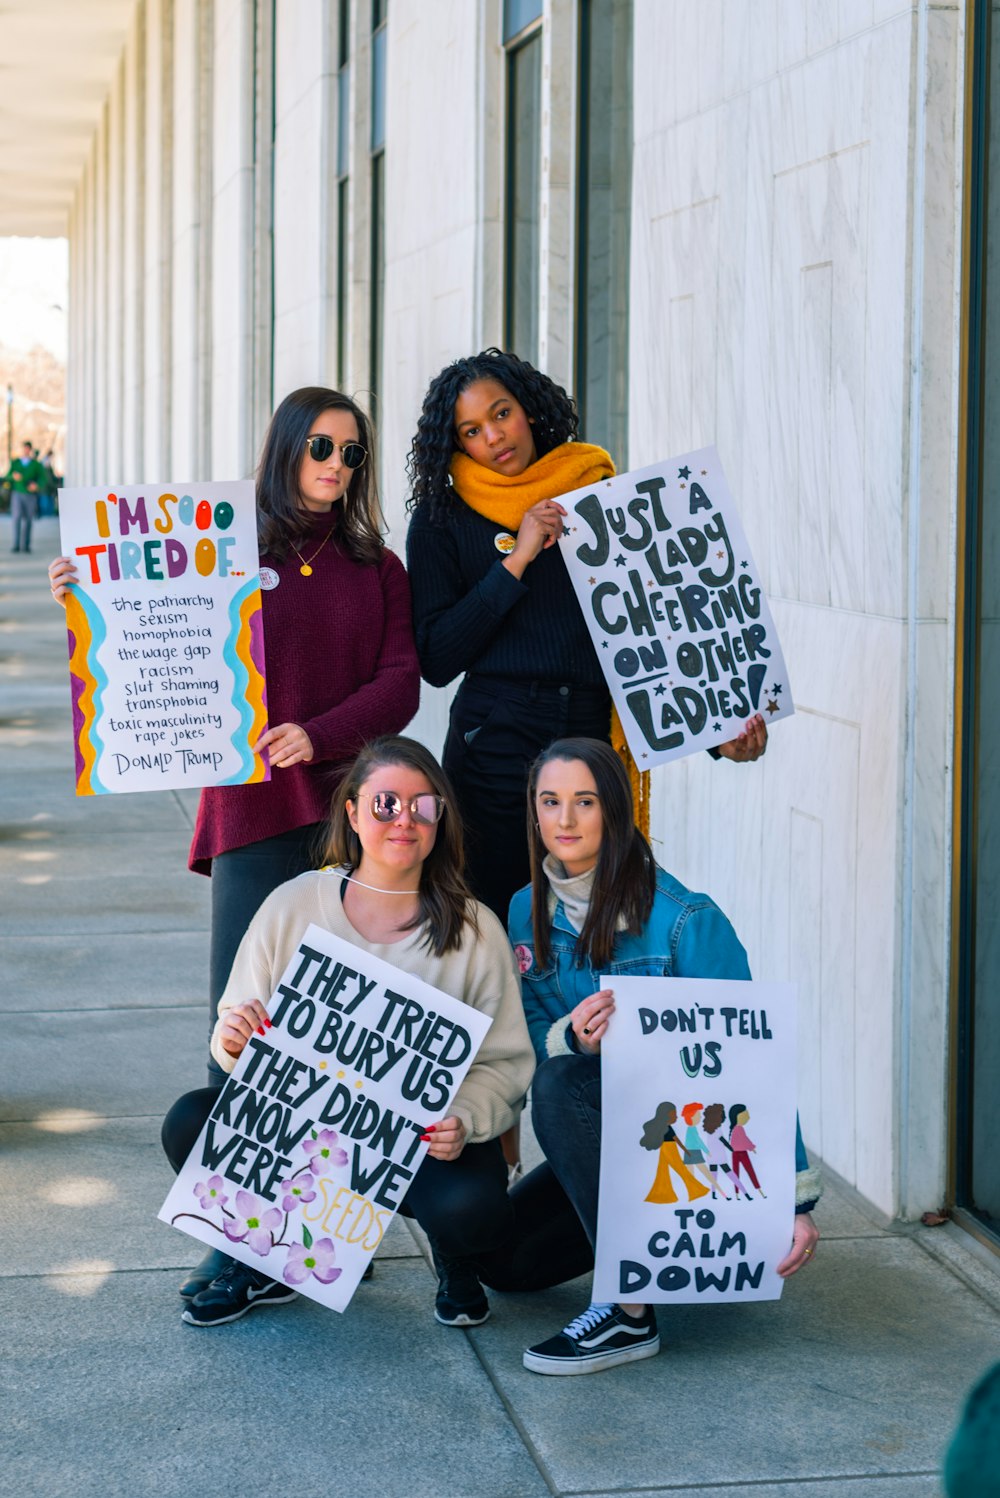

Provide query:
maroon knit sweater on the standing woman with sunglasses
left=189, top=506, right=421, bottom=873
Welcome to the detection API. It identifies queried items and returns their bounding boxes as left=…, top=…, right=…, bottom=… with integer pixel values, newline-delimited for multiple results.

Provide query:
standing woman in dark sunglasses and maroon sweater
left=48, top=386, right=419, bottom=1294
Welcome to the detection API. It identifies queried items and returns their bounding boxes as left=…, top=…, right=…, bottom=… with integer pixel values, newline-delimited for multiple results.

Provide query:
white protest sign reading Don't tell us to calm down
left=594, top=977, right=795, bottom=1303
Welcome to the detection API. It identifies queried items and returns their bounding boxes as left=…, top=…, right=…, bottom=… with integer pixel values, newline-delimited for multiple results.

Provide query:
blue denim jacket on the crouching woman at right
left=507, top=867, right=822, bottom=1212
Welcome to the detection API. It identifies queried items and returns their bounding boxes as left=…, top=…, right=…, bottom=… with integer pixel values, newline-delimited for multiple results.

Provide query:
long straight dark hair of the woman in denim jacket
left=528, top=739, right=656, bottom=968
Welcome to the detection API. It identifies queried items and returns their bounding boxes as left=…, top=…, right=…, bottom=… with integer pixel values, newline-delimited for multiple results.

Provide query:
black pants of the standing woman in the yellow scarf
left=445, top=674, right=611, bottom=926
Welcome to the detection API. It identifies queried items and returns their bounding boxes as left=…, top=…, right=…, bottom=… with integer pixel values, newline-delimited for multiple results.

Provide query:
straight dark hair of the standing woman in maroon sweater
left=257, top=385, right=385, bottom=565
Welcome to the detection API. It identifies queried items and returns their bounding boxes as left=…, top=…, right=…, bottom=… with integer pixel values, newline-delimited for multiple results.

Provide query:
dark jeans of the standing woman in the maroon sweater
left=206, top=822, right=325, bottom=1084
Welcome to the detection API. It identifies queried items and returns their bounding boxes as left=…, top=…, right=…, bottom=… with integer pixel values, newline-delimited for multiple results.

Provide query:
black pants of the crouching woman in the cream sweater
left=160, top=1088, right=513, bottom=1260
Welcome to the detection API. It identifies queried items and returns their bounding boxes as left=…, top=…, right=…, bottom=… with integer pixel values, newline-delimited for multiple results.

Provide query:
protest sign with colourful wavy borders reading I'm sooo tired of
left=60, top=481, right=264, bottom=795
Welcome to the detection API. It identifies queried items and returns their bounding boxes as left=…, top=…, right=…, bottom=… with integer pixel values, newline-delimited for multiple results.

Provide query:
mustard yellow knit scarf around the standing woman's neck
left=451, top=442, right=650, bottom=837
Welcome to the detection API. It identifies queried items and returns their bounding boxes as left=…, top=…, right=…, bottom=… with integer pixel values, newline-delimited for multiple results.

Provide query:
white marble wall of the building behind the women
left=60, top=0, right=964, bottom=1215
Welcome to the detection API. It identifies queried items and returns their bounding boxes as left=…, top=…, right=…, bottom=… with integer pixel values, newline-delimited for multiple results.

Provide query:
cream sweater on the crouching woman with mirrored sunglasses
left=211, top=869, right=534, bottom=1144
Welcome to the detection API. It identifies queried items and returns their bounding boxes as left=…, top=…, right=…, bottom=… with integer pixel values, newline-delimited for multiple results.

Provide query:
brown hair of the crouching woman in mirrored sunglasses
left=323, top=734, right=479, bottom=957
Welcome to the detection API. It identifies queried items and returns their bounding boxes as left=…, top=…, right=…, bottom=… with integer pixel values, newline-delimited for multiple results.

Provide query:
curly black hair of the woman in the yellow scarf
left=406, top=349, right=579, bottom=520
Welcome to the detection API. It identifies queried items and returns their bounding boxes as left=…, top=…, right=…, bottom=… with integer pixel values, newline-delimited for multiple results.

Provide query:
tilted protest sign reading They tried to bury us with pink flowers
left=159, top=924, right=493, bottom=1311
